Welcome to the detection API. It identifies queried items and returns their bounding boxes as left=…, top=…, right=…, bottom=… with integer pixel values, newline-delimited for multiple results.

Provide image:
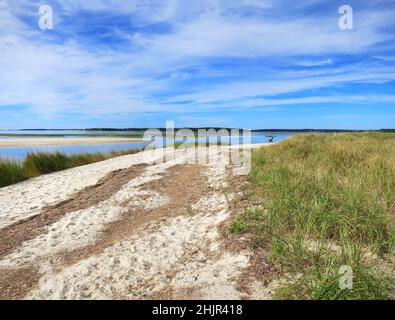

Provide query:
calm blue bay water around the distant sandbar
left=0, top=130, right=297, bottom=160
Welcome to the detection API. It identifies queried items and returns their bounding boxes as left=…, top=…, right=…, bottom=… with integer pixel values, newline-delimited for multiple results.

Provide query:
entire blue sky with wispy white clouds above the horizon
left=0, top=0, right=395, bottom=129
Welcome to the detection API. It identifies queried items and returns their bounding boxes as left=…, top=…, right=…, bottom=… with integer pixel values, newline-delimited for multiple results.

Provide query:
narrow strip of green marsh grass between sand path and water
left=0, top=149, right=139, bottom=187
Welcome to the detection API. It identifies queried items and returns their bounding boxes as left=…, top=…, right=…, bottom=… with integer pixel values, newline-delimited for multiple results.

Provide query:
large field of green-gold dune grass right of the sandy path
left=230, top=132, right=395, bottom=299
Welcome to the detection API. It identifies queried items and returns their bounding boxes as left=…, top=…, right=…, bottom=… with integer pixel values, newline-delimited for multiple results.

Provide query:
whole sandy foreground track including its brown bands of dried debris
left=0, top=147, right=275, bottom=299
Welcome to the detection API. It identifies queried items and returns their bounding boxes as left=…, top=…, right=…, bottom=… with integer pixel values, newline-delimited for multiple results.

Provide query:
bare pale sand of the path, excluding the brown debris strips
left=0, top=147, right=274, bottom=299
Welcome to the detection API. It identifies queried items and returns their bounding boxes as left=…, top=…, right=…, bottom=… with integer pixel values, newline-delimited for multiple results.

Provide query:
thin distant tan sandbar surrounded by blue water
left=0, top=138, right=143, bottom=147
